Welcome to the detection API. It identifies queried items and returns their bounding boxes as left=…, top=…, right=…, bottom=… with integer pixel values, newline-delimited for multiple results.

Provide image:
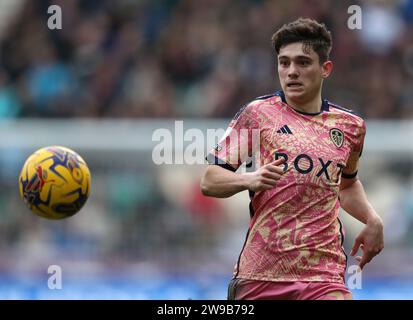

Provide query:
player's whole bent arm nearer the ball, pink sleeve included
left=201, top=102, right=285, bottom=198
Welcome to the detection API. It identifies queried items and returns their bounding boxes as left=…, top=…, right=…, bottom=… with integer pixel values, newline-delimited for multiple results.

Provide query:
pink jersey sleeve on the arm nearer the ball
left=206, top=103, right=260, bottom=171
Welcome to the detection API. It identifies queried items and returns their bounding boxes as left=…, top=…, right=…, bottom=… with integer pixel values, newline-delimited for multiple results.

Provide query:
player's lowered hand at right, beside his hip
left=350, top=217, right=384, bottom=269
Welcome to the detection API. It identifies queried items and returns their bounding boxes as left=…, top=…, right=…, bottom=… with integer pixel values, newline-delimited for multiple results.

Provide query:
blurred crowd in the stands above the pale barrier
left=0, top=0, right=413, bottom=119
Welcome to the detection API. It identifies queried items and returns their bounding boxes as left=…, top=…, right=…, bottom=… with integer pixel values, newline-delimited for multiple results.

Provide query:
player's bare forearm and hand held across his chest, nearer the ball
left=201, top=158, right=285, bottom=198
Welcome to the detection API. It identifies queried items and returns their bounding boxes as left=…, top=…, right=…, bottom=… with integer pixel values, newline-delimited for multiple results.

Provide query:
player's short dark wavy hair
left=271, top=18, right=333, bottom=64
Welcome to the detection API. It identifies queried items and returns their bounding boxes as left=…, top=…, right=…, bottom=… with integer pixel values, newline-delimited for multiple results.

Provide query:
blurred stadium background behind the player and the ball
left=0, top=0, right=413, bottom=299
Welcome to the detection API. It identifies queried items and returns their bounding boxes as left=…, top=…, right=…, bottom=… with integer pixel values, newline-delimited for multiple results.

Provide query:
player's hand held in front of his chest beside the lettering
left=246, top=157, right=286, bottom=192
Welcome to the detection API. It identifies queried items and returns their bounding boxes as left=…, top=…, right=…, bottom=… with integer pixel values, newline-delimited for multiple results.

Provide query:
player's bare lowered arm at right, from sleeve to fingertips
left=340, top=172, right=384, bottom=268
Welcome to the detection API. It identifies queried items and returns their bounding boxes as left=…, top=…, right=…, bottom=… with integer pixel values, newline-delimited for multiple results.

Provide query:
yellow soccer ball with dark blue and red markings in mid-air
left=19, top=146, right=90, bottom=220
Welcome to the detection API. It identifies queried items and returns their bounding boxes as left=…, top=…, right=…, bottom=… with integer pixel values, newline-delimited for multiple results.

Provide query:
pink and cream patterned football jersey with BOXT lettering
left=207, top=91, right=365, bottom=283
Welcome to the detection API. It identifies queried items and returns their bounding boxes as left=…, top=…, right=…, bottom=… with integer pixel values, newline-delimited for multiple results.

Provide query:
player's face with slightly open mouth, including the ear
left=278, top=42, right=332, bottom=103
